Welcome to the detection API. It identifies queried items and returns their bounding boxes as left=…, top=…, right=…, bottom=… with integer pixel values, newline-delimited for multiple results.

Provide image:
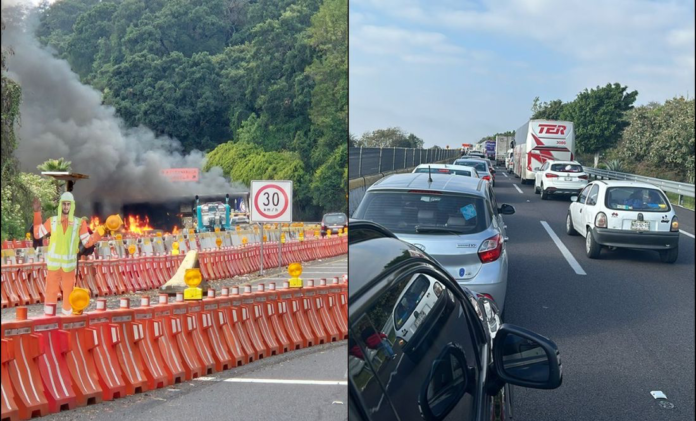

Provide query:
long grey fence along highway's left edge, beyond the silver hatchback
left=348, top=147, right=460, bottom=179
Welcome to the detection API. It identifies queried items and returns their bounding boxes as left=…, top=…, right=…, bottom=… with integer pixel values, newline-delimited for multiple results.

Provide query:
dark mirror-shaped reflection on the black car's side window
left=418, top=342, right=474, bottom=421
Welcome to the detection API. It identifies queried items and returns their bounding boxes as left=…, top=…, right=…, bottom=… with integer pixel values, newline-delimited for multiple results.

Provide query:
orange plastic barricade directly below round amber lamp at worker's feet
left=58, top=314, right=102, bottom=406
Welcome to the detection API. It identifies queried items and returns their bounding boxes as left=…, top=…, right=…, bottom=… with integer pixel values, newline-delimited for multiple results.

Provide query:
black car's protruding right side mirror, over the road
left=493, top=323, right=563, bottom=389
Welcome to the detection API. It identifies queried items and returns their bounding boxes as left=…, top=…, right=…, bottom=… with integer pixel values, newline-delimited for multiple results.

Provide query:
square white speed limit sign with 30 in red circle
left=251, top=180, right=292, bottom=222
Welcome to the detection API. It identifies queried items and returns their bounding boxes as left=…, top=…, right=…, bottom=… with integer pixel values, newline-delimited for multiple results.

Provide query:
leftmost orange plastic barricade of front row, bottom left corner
left=1, top=309, right=50, bottom=420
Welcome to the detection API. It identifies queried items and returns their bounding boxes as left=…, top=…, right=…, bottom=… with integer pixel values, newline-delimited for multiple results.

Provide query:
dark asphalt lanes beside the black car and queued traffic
left=494, top=169, right=694, bottom=421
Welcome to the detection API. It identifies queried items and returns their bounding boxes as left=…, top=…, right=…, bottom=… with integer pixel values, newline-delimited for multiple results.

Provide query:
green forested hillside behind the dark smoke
left=37, top=0, right=348, bottom=216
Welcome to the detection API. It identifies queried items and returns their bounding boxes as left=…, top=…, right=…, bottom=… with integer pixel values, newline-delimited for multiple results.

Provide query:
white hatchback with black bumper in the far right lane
left=566, top=180, right=679, bottom=263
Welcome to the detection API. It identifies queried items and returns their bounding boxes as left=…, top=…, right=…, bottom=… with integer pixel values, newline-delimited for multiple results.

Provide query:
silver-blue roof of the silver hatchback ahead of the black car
left=367, top=173, right=486, bottom=196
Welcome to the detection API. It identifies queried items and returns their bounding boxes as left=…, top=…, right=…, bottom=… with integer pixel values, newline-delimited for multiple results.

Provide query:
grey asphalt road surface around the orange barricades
left=36, top=256, right=348, bottom=421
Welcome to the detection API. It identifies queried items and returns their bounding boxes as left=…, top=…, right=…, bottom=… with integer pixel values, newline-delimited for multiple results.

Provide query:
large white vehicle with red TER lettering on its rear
left=512, top=120, right=575, bottom=184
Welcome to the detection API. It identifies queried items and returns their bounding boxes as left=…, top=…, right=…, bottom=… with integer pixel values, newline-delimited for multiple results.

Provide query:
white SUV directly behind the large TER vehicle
left=534, top=161, right=589, bottom=200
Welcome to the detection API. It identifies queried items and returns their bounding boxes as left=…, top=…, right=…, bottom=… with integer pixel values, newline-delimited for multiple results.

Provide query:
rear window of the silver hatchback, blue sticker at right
left=353, top=190, right=490, bottom=235
